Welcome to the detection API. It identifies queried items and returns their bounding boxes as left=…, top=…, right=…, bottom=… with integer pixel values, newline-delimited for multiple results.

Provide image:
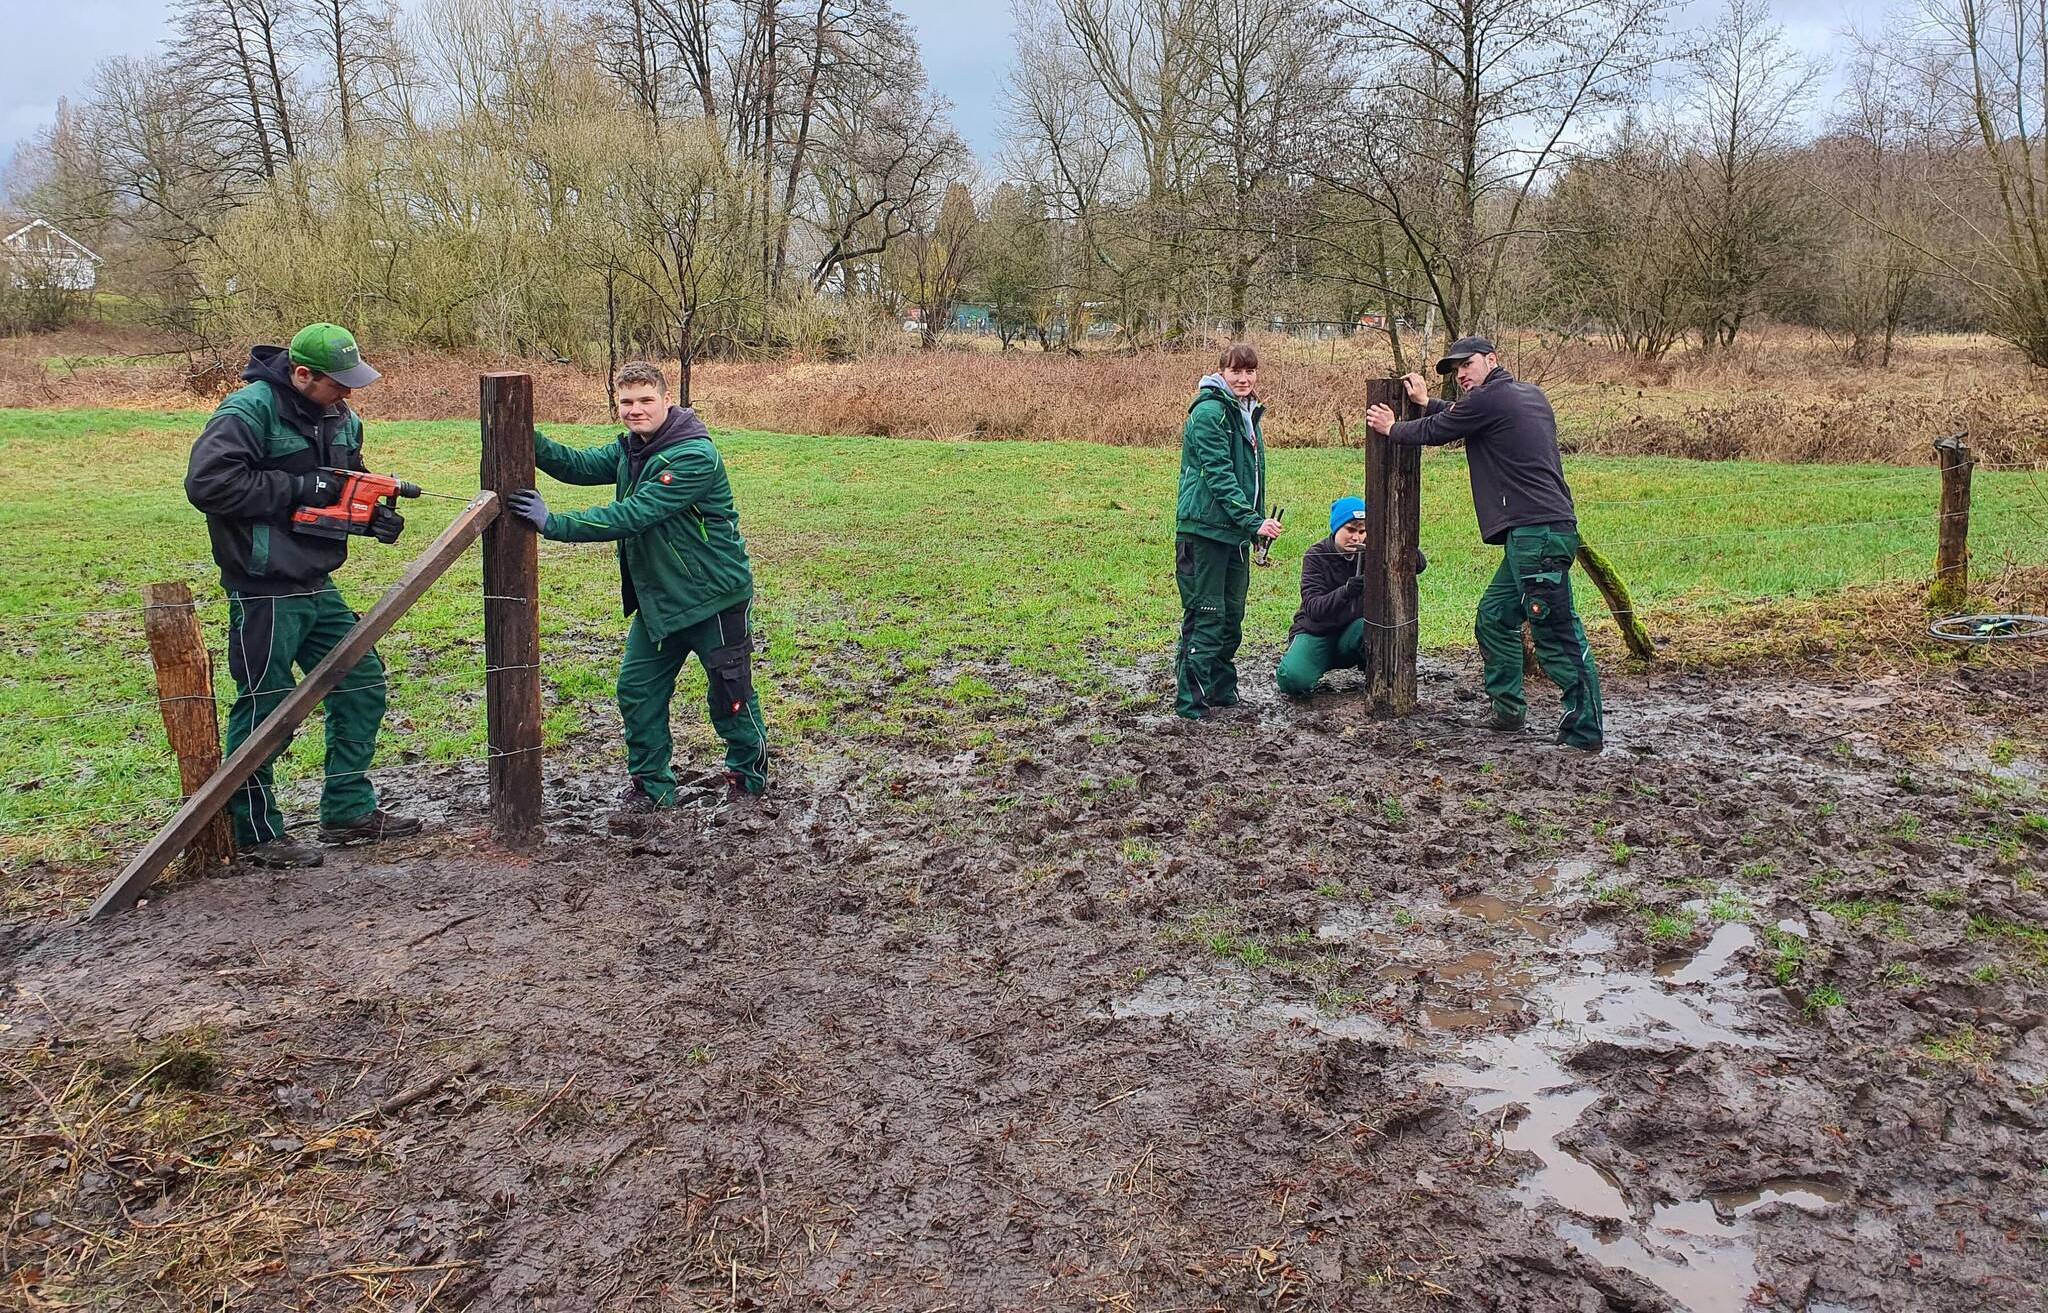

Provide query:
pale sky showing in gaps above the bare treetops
left=0, top=0, right=1884, bottom=180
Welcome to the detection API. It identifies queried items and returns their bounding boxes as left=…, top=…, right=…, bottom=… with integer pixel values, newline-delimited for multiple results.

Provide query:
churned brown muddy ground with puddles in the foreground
left=0, top=662, right=2048, bottom=1313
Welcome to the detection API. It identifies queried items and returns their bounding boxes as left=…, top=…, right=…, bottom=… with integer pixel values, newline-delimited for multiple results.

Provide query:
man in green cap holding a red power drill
left=184, top=324, right=420, bottom=866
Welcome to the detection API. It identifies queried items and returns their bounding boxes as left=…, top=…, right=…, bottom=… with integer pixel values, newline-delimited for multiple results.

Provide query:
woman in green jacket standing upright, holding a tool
left=1174, top=342, right=1280, bottom=721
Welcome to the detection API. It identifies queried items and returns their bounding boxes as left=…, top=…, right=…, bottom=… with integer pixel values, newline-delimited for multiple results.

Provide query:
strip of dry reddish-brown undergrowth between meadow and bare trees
left=0, top=328, right=2048, bottom=465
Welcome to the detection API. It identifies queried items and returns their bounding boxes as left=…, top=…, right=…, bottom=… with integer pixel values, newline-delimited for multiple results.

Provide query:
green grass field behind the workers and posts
left=0, top=410, right=2048, bottom=860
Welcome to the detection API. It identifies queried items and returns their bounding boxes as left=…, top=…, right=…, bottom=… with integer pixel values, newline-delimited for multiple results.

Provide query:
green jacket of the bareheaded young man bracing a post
left=535, top=406, right=754, bottom=643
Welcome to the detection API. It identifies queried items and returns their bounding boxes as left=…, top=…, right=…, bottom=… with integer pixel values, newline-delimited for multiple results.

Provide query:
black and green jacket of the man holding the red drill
left=184, top=346, right=365, bottom=594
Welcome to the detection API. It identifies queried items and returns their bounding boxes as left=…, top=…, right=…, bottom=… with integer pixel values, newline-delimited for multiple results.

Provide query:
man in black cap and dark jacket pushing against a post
left=1366, top=338, right=1606, bottom=752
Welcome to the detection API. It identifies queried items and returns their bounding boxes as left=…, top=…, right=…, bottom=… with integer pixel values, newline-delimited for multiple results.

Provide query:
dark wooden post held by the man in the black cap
left=1364, top=379, right=1421, bottom=717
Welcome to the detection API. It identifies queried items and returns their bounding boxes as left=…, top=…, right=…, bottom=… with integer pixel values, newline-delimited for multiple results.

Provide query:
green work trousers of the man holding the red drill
left=227, top=588, right=385, bottom=848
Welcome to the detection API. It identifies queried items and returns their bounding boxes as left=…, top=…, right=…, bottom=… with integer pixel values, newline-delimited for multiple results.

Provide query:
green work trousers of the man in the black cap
left=1473, top=524, right=1606, bottom=748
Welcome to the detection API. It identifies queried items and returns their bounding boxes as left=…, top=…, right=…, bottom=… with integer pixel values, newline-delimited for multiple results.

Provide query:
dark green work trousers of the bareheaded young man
left=618, top=604, right=768, bottom=807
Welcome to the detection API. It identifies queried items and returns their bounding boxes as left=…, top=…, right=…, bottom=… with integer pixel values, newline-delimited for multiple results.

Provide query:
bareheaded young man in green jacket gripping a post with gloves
left=506, top=363, right=768, bottom=813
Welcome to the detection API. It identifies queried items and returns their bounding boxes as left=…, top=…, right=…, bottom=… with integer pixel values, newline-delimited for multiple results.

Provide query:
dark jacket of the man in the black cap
left=1386, top=367, right=1579, bottom=543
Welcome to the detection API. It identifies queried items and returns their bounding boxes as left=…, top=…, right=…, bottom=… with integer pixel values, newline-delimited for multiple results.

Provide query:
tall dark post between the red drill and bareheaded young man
left=481, top=373, right=541, bottom=848
